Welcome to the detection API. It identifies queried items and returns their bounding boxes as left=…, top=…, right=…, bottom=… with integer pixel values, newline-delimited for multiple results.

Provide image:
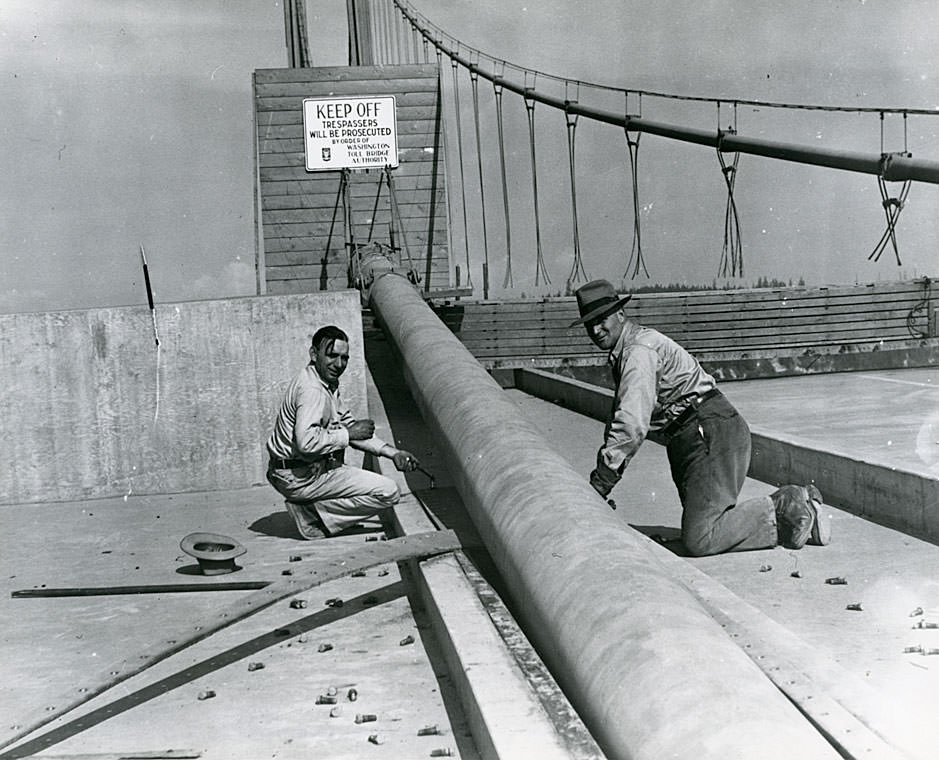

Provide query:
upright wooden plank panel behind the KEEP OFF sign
left=254, top=64, right=451, bottom=293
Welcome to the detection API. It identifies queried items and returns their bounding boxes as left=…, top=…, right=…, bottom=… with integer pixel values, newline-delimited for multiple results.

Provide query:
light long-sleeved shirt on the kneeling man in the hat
left=597, top=320, right=717, bottom=473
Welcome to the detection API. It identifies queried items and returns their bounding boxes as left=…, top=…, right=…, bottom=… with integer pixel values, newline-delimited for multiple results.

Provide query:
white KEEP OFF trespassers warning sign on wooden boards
left=303, top=95, right=398, bottom=172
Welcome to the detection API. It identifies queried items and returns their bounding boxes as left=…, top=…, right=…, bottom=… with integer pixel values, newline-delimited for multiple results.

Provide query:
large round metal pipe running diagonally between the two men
left=363, top=262, right=837, bottom=760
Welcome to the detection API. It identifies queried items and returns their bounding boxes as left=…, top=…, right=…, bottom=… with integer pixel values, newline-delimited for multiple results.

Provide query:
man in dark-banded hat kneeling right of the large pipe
left=571, top=280, right=831, bottom=556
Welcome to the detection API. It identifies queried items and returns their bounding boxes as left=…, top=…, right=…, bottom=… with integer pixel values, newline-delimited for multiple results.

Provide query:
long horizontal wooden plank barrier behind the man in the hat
left=422, top=280, right=939, bottom=367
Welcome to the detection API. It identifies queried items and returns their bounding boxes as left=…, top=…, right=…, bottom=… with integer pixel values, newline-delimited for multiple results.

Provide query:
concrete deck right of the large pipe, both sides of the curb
left=507, top=370, right=939, bottom=758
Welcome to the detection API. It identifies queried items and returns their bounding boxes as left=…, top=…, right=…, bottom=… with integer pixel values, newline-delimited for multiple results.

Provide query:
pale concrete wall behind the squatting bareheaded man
left=0, top=290, right=366, bottom=504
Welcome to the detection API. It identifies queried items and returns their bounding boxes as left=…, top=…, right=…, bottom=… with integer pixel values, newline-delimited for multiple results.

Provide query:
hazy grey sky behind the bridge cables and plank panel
left=0, top=0, right=939, bottom=313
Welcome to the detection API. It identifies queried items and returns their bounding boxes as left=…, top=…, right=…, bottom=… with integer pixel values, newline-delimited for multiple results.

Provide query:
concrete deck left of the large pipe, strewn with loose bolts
left=0, top=487, right=477, bottom=759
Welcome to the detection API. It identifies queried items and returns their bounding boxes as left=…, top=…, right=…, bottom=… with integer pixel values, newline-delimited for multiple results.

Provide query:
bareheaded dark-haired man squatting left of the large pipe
left=267, top=325, right=420, bottom=539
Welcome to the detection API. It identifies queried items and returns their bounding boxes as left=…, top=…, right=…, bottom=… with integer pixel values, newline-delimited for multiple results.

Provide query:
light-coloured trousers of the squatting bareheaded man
left=267, top=465, right=401, bottom=533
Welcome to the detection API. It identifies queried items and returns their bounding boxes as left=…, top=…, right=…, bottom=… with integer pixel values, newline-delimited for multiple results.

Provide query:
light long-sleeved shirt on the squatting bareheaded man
left=267, top=363, right=385, bottom=462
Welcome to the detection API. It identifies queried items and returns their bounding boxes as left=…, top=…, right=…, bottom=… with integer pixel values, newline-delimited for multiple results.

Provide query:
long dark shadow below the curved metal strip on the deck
left=0, top=581, right=407, bottom=760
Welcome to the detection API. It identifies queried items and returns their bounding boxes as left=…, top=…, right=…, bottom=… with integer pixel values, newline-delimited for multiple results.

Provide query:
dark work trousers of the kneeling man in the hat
left=667, top=394, right=777, bottom=557
